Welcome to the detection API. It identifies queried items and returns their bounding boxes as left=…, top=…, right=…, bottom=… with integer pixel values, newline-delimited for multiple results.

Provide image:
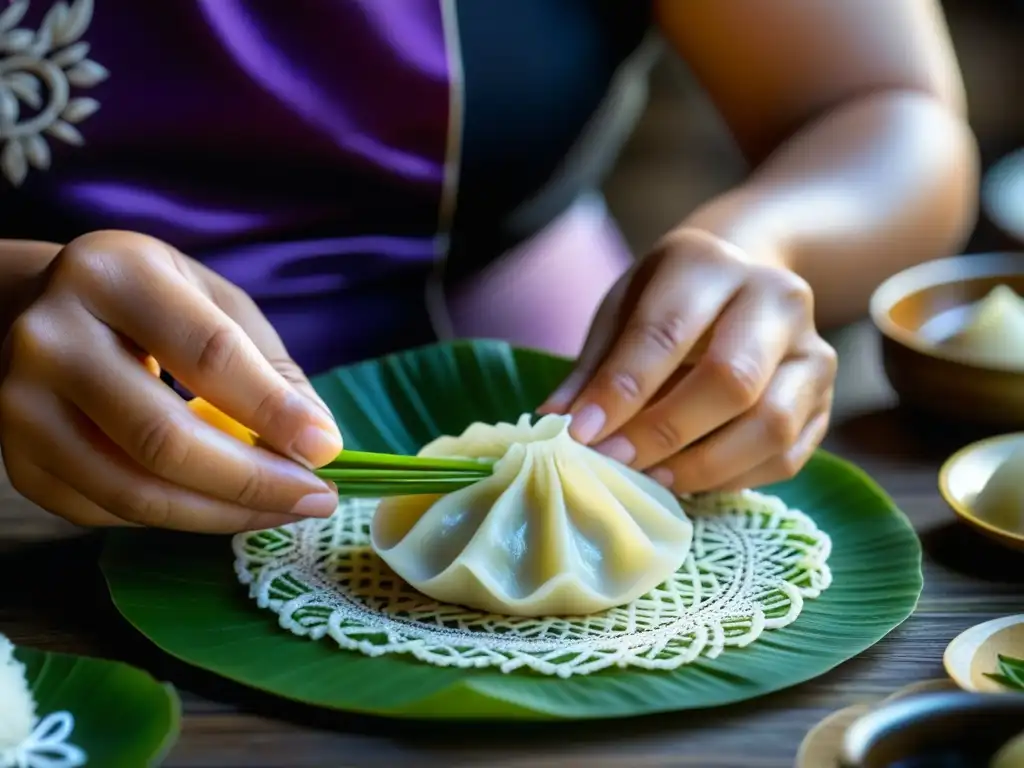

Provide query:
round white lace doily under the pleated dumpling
left=232, top=492, right=831, bottom=678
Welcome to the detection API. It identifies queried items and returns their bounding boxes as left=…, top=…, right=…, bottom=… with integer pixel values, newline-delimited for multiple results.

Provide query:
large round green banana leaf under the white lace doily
left=101, top=341, right=922, bottom=720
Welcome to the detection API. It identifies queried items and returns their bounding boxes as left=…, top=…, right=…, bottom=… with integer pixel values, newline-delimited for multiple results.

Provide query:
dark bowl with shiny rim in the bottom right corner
left=840, top=691, right=1024, bottom=768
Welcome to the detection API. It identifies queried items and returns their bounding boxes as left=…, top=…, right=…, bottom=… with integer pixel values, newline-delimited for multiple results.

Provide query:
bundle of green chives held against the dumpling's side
left=316, top=451, right=494, bottom=498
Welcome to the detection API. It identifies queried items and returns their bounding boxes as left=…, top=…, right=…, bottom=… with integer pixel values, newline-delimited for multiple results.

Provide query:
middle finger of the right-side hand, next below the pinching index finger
left=596, top=274, right=803, bottom=470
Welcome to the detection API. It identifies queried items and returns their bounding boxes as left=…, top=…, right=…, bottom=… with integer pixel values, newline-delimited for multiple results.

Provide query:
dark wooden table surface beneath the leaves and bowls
left=0, top=327, right=1024, bottom=768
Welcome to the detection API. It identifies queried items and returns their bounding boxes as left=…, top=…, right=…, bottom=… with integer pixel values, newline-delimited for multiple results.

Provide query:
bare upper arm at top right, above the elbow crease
left=655, top=0, right=966, bottom=161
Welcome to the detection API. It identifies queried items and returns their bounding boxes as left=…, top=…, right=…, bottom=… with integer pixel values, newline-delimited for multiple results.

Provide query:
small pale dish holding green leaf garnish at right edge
left=942, top=613, right=1024, bottom=696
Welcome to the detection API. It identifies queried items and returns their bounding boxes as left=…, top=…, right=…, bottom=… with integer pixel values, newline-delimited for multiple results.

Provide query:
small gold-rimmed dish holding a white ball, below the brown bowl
left=939, top=432, right=1024, bottom=551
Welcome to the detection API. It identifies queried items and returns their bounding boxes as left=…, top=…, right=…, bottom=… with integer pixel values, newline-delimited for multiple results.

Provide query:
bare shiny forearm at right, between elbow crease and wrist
left=685, top=91, right=978, bottom=327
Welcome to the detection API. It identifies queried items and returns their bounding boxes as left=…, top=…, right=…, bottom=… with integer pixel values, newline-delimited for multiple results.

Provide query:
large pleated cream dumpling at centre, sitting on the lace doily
left=371, top=414, right=693, bottom=616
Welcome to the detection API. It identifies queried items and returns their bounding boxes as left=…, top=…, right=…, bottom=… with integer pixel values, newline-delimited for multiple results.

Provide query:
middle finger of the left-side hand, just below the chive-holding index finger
left=12, top=303, right=337, bottom=516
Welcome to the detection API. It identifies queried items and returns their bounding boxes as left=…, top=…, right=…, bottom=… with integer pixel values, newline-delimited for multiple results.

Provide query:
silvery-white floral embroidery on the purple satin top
left=0, top=0, right=109, bottom=186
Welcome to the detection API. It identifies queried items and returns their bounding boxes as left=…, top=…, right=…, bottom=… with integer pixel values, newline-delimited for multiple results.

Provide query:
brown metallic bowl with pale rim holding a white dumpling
left=870, top=253, right=1024, bottom=428
